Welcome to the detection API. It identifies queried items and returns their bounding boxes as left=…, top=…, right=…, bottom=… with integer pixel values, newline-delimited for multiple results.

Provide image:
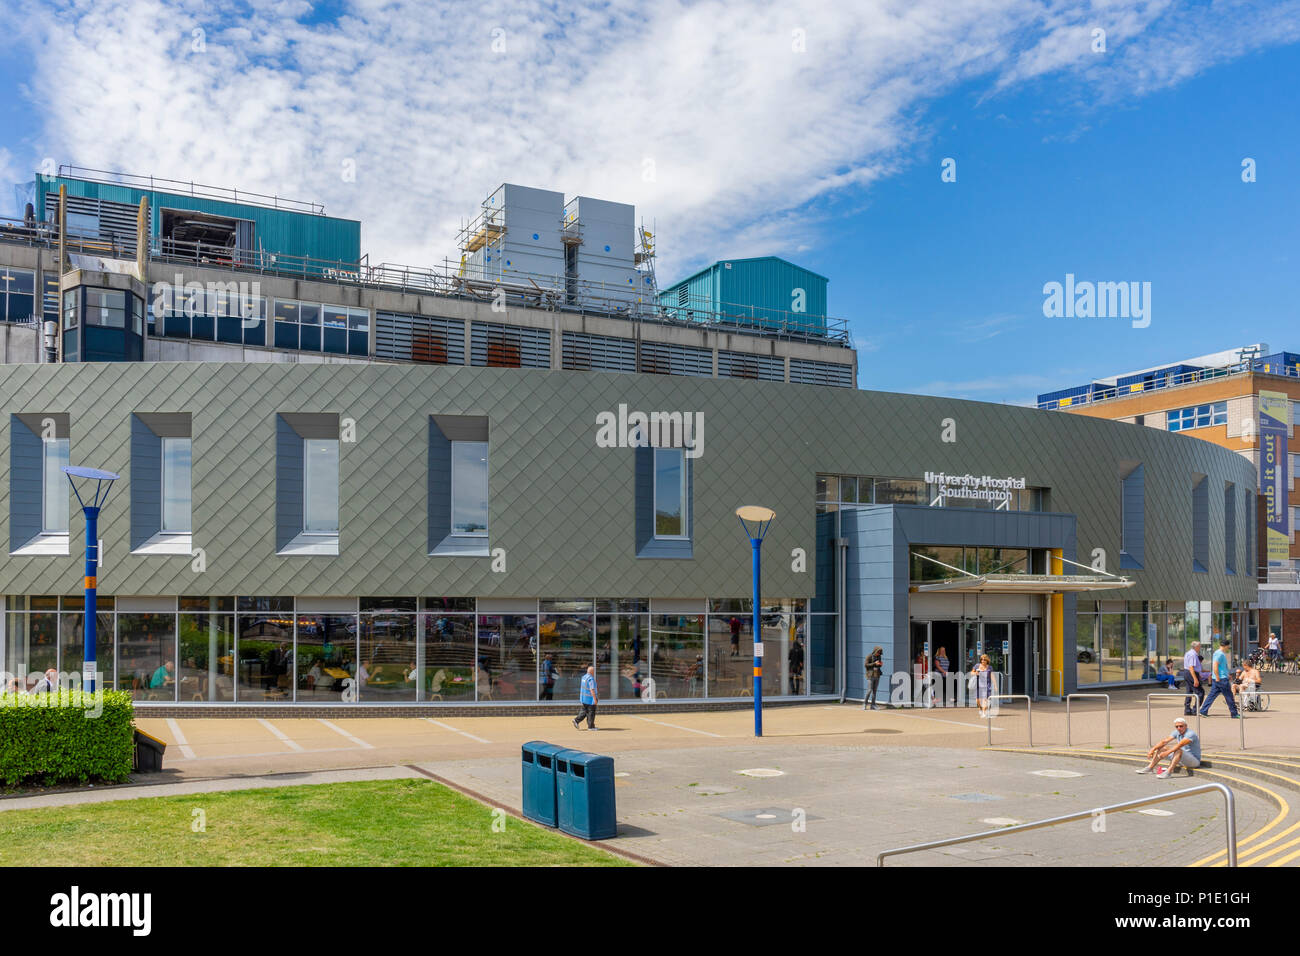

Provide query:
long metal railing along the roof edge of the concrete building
left=0, top=219, right=849, bottom=347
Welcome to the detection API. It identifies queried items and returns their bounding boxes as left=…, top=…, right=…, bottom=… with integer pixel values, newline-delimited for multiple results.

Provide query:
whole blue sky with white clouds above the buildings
left=0, top=0, right=1300, bottom=402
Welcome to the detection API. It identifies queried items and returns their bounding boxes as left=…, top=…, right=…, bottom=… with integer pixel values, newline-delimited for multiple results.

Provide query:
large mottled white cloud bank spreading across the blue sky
left=10, top=0, right=1300, bottom=278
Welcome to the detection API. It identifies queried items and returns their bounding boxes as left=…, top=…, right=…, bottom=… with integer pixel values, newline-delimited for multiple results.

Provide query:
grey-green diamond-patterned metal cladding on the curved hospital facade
left=0, top=363, right=1257, bottom=601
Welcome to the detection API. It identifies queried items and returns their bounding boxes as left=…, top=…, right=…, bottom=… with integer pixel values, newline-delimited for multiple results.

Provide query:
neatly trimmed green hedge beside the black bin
left=0, top=691, right=135, bottom=787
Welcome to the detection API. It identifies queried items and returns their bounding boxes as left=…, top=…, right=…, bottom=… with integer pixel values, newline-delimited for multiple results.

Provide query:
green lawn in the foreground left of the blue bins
left=0, top=780, right=632, bottom=866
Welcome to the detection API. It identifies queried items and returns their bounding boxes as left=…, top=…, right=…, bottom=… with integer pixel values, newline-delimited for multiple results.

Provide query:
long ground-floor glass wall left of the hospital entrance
left=3, top=594, right=821, bottom=704
